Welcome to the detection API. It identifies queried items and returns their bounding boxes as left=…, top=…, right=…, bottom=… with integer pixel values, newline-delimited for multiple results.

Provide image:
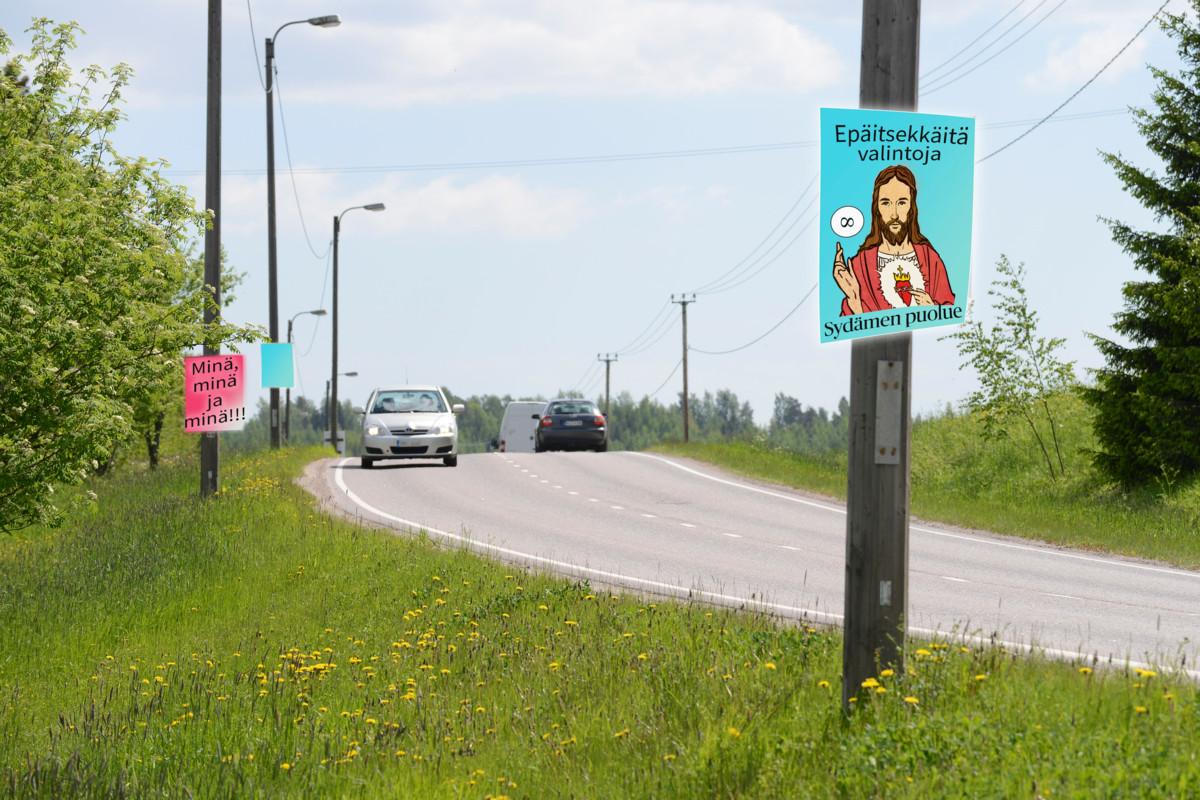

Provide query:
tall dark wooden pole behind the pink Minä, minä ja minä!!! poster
left=200, top=0, right=221, bottom=498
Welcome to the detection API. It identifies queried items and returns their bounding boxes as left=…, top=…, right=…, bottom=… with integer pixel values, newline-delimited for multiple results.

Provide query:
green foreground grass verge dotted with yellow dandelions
left=0, top=451, right=1200, bottom=798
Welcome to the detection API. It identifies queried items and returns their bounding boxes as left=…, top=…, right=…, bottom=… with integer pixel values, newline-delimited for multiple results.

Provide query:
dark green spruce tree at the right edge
left=1084, top=0, right=1200, bottom=487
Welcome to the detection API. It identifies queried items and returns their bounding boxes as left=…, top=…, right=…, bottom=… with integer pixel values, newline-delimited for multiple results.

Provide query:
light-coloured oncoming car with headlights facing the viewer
left=361, top=386, right=463, bottom=469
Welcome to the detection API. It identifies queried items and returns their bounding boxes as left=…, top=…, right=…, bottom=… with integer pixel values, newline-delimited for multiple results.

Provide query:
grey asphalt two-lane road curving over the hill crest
left=317, top=452, right=1200, bottom=678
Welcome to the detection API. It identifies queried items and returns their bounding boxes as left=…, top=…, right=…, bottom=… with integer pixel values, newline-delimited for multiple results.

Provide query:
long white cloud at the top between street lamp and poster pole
left=283, top=0, right=845, bottom=107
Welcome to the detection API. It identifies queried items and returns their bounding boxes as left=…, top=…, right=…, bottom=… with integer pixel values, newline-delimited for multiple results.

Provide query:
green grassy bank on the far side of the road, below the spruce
left=655, top=396, right=1200, bottom=569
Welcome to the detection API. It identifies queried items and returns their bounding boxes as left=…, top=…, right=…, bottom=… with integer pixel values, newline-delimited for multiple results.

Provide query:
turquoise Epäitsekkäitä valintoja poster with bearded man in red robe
left=820, top=108, right=974, bottom=342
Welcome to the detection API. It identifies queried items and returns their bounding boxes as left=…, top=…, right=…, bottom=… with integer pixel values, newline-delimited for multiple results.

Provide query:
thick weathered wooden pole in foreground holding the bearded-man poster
left=841, top=0, right=920, bottom=709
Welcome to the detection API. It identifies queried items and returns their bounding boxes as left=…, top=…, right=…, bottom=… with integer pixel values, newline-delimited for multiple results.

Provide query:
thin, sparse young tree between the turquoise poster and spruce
left=942, top=255, right=1075, bottom=479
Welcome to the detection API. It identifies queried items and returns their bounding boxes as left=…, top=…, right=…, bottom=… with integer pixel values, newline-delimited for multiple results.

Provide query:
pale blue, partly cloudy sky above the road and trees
left=0, top=0, right=1183, bottom=421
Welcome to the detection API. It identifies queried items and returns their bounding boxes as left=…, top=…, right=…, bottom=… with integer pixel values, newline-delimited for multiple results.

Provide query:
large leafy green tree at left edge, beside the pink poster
left=0, top=19, right=251, bottom=530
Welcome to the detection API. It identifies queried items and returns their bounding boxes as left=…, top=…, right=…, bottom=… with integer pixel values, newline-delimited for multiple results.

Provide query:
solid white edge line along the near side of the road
left=335, top=458, right=1200, bottom=680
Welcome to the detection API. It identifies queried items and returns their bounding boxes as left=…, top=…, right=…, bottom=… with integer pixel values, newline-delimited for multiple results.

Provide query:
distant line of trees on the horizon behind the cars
left=221, top=389, right=864, bottom=455
